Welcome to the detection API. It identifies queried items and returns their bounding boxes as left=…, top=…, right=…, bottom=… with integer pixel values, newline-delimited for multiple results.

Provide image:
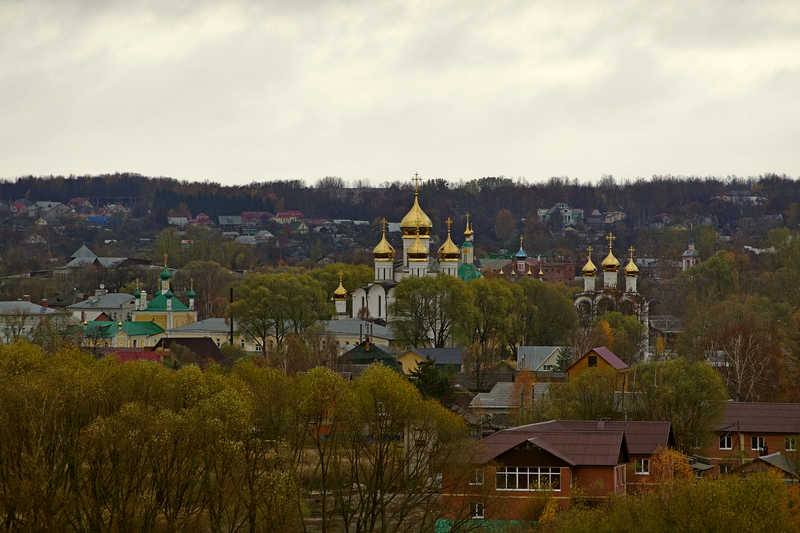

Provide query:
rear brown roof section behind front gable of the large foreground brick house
left=523, top=420, right=675, bottom=455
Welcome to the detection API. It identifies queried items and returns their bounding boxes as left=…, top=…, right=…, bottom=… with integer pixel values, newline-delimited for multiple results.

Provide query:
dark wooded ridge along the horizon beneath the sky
left=6, top=173, right=800, bottom=235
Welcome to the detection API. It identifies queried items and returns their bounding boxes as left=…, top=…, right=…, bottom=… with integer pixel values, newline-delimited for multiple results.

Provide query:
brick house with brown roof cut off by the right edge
left=702, top=402, right=800, bottom=474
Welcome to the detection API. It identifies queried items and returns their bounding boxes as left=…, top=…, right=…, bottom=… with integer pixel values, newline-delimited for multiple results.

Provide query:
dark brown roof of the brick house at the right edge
left=717, top=402, right=800, bottom=435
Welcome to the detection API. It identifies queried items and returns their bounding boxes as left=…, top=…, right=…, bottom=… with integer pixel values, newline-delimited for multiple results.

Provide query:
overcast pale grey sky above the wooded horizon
left=0, top=0, right=800, bottom=184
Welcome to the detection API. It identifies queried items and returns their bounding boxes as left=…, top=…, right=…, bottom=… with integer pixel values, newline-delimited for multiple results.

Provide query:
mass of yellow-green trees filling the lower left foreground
left=0, top=343, right=467, bottom=532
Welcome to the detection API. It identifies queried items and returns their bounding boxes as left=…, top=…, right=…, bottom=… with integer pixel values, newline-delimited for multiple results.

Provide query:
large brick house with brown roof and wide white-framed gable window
left=437, top=420, right=674, bottom=529
